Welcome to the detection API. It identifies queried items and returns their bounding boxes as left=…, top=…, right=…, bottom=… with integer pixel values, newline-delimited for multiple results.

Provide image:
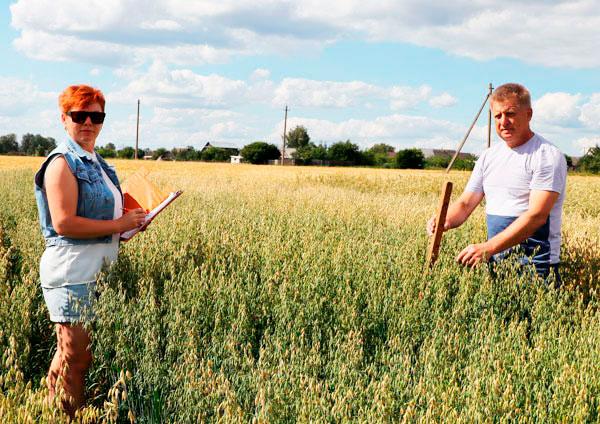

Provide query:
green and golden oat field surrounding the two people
left=0, top=156, right=600, bottom=423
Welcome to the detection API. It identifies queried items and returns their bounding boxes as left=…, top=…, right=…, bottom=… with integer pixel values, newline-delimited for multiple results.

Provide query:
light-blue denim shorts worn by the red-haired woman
left=42, top=283, right=98, bottom=323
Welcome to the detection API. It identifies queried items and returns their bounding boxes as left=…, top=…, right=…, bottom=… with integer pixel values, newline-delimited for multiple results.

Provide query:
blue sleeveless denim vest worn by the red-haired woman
left=34, top=139, right=122, bottom=246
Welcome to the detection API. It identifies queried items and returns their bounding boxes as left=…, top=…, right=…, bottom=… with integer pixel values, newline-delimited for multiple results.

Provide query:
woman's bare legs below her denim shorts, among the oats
left=48, top=323, right=92, bottom=416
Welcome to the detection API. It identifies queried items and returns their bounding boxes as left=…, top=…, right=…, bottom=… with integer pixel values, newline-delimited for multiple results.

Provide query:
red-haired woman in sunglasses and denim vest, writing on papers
left=35, top=85, right=145, bottom=416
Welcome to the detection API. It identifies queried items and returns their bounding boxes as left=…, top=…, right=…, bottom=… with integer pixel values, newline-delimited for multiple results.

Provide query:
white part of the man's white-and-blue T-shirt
left=465, top=134, right=567, bottom=264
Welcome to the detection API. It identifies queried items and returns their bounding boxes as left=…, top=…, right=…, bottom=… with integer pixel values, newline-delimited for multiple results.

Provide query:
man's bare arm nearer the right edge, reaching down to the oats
left=456, top=190, right=559, bottom=266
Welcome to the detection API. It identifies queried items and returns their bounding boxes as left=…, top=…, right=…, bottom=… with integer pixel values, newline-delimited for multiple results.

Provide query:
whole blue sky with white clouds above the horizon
left=0, top=0, right=600, bottom=155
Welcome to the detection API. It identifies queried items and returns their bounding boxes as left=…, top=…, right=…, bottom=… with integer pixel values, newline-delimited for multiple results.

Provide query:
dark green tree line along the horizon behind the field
left=0, top=125, right=600, bottom=174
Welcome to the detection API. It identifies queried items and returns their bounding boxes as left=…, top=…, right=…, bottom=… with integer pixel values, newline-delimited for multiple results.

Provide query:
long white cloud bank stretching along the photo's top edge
left=10, top=0, right=600, bottom=68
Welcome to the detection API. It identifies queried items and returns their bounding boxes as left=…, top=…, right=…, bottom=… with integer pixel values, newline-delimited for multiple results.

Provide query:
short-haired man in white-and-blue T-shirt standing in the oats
left=427, top=83, right=567, bottom=282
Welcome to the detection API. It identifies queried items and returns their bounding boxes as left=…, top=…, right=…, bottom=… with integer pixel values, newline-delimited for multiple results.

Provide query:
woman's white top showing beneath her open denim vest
left=40, top=152, right=123, bottom=288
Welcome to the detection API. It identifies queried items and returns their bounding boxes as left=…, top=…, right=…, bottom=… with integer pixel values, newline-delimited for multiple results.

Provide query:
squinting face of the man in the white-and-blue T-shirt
left=491, top=96, right=533, bottom=147
